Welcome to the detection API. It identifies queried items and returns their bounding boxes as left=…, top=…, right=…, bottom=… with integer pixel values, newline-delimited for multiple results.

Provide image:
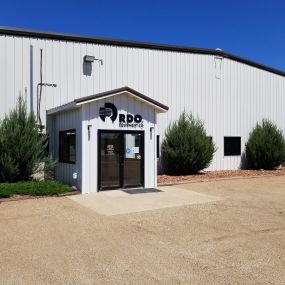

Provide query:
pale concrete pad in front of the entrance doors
left=68, top=186, right=222, bottom=216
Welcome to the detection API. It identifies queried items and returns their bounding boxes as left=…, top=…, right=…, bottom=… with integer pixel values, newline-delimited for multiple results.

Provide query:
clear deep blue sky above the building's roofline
left=0, top=0, right=285, bottom=71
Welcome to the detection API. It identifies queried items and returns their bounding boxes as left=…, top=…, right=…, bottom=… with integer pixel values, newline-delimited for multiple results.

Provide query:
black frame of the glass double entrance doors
left=97, top=129, right=145, bottom=191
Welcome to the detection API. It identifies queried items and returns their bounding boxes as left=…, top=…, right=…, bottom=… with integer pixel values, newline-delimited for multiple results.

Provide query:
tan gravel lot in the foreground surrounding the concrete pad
left=0, top=176, right=285, bottom=285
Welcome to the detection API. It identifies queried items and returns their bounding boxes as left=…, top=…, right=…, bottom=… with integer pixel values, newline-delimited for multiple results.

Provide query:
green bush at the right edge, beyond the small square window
left=245, top=119, right=285, bottom=169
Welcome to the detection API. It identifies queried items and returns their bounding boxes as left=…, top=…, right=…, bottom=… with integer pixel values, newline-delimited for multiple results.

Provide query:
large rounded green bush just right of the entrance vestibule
left=161, top=112, right=216, bottom=175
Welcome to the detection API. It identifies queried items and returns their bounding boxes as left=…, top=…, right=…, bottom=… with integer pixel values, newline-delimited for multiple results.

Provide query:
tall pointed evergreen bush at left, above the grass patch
left=0, top=97, right=47, bottom=182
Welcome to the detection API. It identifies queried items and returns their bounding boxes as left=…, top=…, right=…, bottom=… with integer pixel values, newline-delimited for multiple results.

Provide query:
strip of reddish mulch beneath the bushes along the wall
left=157, top=167, right=285, bottom=186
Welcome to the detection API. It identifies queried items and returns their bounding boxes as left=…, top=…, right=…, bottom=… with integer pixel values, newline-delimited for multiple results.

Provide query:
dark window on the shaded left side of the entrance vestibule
left=59, top=130, right=76, bottom=163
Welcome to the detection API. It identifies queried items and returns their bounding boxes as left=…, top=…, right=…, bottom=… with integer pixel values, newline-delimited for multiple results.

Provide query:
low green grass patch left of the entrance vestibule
left=0, top=181, right=71, bottom=198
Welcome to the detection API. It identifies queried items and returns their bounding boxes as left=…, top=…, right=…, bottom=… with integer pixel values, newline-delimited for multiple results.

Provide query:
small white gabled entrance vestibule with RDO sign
left=47, top=87, right=168, bottom=193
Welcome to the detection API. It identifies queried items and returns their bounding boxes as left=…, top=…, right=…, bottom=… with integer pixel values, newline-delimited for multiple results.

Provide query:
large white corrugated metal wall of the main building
left=0, top=36, right=285, bottom=169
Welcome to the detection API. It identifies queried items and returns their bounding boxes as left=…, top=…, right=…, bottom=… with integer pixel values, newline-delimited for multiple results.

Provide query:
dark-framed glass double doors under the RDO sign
left=98, top=131, right=144, bottom=190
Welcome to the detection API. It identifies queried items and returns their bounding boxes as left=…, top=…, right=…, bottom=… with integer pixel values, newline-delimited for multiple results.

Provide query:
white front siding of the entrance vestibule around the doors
left=80, top=95, right=156, bottom=193
